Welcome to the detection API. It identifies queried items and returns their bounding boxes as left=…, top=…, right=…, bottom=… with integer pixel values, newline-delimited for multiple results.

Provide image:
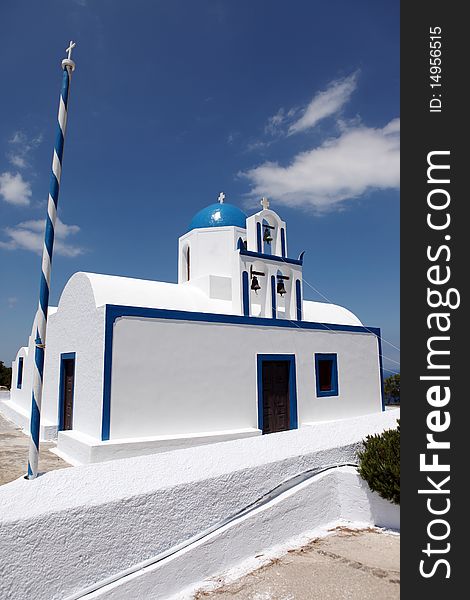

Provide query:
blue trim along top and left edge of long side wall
left=101, top=304, right=380, bottom=441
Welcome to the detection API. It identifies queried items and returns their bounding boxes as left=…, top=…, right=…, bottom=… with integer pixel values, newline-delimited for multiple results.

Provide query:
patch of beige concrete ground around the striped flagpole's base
left=0, top=415, right=70, bottom=485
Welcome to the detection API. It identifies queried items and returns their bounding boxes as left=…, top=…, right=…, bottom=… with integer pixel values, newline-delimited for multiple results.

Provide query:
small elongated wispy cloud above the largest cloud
left=288, top=71, right=358, bottom=135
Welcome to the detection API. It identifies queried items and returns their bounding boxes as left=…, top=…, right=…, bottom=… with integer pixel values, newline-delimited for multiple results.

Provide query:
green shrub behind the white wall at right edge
left=358, top=421, right=400, bottom=504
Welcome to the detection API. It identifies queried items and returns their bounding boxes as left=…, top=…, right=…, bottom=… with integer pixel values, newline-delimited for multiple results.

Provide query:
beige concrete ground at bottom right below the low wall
left=195, top=528, right=400, bottom=600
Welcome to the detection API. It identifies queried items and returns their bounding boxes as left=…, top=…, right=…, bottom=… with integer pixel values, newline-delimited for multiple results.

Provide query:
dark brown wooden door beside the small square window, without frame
left=263, top=360, right=290, bottom=433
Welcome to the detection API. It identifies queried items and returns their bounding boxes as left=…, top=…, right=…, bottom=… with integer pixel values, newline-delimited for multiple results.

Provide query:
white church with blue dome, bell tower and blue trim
left=1, top=194, right=383, bottom=464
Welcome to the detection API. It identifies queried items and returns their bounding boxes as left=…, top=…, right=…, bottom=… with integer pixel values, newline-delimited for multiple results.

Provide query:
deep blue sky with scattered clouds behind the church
left=0, top=0, right=399, bottom=374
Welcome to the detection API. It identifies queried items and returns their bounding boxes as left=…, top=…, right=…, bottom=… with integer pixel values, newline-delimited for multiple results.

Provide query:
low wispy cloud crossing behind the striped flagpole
left=0, top=218, right=84, bottom=258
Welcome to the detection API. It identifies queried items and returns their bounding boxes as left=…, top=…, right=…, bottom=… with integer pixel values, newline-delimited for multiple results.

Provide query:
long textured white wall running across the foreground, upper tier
left=0, top=411, right=399, bottom=600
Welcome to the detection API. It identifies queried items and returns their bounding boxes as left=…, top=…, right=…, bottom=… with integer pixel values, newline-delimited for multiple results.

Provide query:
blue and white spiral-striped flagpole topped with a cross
left=27, top=42, right=75, bottom=479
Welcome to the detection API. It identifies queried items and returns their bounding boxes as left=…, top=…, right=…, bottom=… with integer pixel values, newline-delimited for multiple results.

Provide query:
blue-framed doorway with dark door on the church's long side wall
left=258, top=354, right=297, bottom=434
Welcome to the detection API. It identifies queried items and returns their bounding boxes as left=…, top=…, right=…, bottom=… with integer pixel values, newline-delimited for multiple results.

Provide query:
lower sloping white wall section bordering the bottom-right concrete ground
left=87, top=467, right=400, bottom=600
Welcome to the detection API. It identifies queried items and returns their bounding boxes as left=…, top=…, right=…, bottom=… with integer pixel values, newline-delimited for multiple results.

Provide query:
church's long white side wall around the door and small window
left=110, top=317, right=381, bottom=439
